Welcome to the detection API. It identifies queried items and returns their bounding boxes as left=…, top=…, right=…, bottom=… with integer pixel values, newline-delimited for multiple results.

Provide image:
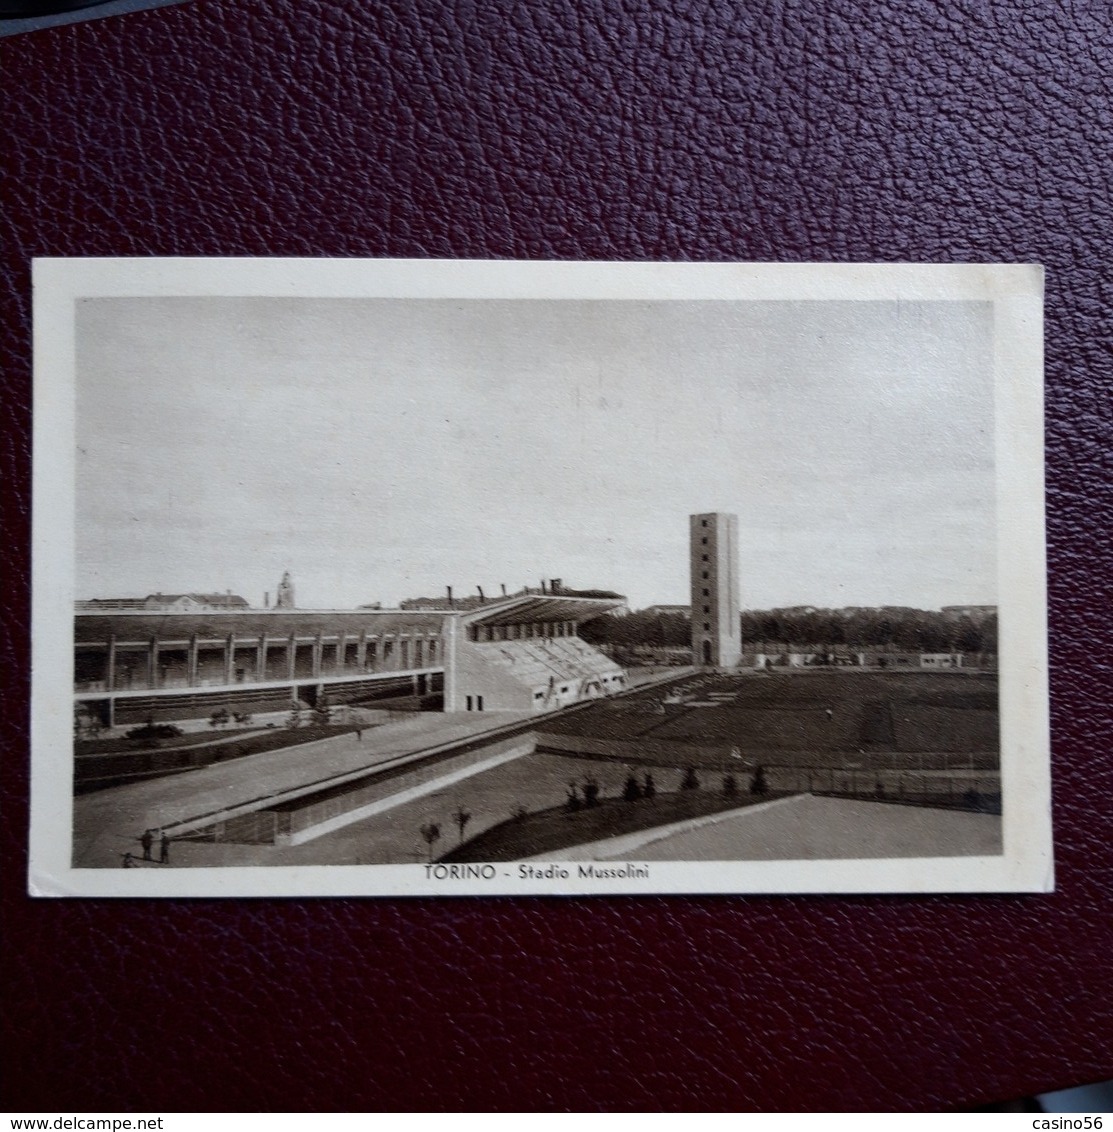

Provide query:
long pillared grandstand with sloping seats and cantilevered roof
left=74, top=585, right=626, bottom=730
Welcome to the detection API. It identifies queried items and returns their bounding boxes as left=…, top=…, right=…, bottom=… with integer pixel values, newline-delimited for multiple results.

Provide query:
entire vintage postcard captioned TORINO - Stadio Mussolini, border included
left=31, top=259, right=1053, bottom=897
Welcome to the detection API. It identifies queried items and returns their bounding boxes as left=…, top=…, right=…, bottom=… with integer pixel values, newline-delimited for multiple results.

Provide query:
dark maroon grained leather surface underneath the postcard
left=0, top=0, right=1113, bottom=1110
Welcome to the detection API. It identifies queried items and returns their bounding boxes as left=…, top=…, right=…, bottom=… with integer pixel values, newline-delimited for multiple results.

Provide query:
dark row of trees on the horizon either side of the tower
left=580, top=608, right=998, bottom=653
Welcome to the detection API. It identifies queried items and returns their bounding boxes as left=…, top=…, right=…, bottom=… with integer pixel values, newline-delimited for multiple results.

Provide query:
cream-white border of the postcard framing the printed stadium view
left=28, top=258, right=1053, bottom=897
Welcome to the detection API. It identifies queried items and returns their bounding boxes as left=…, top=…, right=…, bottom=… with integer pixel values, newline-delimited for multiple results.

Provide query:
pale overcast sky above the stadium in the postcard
left=76, top=298, right=996, bottom=609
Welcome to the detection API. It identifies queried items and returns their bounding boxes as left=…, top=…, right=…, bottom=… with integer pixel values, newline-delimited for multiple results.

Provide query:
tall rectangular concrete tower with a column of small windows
left=688, top=512, right=742, bottom=668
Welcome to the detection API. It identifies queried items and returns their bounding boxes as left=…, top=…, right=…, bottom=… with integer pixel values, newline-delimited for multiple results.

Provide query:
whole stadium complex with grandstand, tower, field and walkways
left=74, top=513, right=1001, bottom=867
